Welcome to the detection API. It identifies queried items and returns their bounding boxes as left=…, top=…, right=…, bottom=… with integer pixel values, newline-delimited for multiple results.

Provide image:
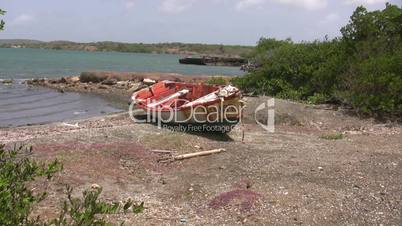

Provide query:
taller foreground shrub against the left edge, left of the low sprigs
left=0, top=145, right=62, bottom=225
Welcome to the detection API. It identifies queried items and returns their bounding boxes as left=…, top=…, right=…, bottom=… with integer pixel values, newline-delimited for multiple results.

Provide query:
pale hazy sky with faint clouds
left=0, top=0, right=402, bottom=45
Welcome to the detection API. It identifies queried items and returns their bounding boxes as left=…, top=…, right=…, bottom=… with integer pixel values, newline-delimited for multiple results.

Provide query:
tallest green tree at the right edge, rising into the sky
left=341, top=3, right=402, bottom=115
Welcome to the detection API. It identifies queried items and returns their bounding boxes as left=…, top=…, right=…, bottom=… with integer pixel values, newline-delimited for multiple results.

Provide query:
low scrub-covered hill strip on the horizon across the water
left=0, top=39, right=254, bottom=57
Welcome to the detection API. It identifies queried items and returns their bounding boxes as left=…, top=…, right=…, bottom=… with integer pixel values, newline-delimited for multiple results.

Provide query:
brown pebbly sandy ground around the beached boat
left=0, top=92, right=402, bottom=225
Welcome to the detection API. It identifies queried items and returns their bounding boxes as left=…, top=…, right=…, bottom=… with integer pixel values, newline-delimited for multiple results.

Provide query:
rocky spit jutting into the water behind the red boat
left=25, top=71, right=231, bottom=108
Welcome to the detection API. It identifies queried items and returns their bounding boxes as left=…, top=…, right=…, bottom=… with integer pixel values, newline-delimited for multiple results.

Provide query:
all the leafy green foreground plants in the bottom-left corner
left=0, top=145, right=143, bottom=225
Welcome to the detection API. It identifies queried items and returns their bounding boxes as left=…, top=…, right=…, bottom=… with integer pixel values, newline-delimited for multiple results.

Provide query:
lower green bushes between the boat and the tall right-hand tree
left=233, top=40, right=343, bottom=100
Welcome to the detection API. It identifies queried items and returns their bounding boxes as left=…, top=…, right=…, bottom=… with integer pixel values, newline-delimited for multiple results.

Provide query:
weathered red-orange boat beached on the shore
left=132, top=81, right=241, bottom=132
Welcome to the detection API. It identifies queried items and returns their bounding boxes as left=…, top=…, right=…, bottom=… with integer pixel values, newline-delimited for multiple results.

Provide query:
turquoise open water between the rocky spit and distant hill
left=0, top=48, right=242, bottom=79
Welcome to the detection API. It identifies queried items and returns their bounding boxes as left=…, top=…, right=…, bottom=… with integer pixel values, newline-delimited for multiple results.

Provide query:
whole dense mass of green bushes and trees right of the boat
left=233, top=3, right=402, bottom=117
